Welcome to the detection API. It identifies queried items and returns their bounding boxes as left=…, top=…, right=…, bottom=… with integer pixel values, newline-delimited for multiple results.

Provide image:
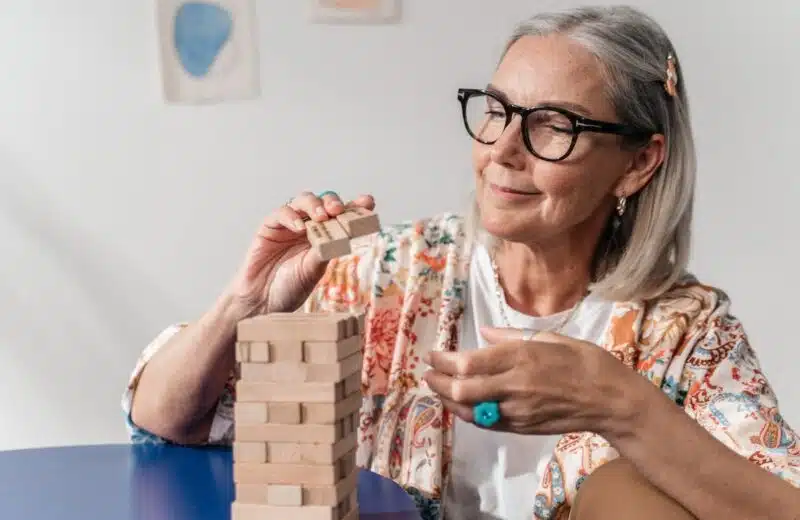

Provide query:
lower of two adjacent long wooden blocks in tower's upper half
left=236, top=380, right=340, bottom=403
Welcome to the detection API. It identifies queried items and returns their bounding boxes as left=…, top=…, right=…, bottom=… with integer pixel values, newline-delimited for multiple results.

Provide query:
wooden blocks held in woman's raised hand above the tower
left=306, top=207, right=380, bottom=260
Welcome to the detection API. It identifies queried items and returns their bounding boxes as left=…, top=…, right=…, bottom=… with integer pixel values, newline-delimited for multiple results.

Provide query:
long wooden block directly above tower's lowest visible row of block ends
left=233, top=462, right=342, bottom=486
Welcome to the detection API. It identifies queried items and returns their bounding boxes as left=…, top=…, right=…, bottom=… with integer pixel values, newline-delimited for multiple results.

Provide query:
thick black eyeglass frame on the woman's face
left=458, top=88, right=656, bottom=162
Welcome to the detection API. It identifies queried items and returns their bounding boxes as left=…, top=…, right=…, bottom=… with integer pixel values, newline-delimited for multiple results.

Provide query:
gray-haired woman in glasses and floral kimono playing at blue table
left=123, top=7, right=800, bottom=520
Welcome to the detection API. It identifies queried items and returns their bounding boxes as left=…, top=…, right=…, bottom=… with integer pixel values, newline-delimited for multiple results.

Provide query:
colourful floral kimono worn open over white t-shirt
left=123, top=214, right=800, bottom=520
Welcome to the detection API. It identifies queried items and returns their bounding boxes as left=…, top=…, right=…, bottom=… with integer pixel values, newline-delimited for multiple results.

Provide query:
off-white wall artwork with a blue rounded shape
left=155, top=0, right=261, bottom=104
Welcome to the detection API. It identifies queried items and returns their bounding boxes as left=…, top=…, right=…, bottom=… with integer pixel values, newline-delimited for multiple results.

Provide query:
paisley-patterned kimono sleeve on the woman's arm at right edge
left=682, top=315, right=800, bottom=488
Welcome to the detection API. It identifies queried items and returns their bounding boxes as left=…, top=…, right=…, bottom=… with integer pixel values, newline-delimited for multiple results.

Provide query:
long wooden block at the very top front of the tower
left=236, top=312, right=358, bottom=344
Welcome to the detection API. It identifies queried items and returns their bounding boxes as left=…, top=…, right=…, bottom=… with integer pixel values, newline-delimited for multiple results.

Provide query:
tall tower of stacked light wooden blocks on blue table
left=231, top=313, right=364, bottom=520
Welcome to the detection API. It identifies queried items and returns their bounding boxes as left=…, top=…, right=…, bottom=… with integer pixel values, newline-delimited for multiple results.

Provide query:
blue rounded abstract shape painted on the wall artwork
left=173, top=2, right=233, bottom=78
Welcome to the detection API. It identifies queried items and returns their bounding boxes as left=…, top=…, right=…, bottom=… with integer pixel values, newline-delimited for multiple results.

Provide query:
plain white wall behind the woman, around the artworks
left=0, top=0, right=800, bottom=449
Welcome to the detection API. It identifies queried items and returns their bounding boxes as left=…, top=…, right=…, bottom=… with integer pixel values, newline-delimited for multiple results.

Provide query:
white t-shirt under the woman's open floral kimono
left=444, top=245, right=613, bottom=520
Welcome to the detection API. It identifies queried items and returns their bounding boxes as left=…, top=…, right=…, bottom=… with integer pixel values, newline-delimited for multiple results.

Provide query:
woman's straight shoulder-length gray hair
left=468, top=6, right=696, bottom=301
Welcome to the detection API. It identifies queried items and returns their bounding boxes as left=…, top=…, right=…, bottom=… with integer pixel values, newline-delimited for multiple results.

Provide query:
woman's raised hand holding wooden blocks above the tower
left=226, top=192, right=375, bottom=319
